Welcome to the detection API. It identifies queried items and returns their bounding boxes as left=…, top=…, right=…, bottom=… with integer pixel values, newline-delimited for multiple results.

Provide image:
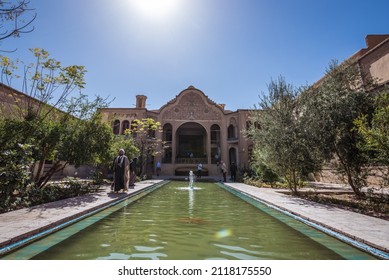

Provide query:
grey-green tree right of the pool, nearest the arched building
left=247, top=77, right=319, bottom=194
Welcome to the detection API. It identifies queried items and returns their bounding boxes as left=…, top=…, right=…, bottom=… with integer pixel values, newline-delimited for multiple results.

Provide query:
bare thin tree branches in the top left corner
left=0, top=0, right=36, bottom=44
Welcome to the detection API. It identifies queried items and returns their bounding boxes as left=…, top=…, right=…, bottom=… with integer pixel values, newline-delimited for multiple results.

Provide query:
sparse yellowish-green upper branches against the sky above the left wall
left=0, top=48, right=86, bottom=120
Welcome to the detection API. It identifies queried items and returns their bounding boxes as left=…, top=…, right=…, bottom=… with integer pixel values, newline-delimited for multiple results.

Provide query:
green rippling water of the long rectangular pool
left=5, top=182, right=371, bottom=260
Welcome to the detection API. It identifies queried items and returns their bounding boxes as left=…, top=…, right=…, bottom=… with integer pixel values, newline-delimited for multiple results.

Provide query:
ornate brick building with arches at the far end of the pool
left=98, top=86, right=251, bottom=176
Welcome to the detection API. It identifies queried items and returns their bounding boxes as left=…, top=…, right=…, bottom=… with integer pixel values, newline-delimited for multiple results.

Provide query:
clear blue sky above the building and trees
left=0, top=0, right=389, bottom=111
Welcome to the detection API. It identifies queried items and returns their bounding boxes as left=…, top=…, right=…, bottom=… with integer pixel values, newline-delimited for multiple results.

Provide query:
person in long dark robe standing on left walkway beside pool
left=113, top=149, right=130, bottom=193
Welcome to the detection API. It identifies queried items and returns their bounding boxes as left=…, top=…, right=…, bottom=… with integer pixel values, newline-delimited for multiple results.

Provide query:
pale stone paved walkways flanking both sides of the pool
left=0, top=178, right=389, bottom=258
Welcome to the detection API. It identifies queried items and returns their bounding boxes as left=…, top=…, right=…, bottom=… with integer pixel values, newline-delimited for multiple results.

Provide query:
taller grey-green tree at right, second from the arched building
left=300, top=61, right=373, bottom=196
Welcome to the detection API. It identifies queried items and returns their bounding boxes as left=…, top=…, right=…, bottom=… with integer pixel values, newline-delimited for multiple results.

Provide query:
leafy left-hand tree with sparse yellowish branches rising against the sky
left=0, top=49, right=112, bottom=188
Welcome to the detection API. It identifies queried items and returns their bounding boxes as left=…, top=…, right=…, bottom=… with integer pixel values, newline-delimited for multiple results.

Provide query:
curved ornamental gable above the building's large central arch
left=162, top=91, right=221, bottom=120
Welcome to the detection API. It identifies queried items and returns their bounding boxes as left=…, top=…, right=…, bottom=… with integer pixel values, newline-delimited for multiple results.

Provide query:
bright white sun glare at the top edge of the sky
left=130, top=0, right=180, bottom=19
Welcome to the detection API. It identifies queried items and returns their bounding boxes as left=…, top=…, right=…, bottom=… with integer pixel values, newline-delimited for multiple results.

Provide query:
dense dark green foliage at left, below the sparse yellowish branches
left=0, top=112, right=113, bottom=191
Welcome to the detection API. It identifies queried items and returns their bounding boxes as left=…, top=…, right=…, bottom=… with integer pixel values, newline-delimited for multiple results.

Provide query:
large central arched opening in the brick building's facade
left=175, top=122, right=207, bottom=164
